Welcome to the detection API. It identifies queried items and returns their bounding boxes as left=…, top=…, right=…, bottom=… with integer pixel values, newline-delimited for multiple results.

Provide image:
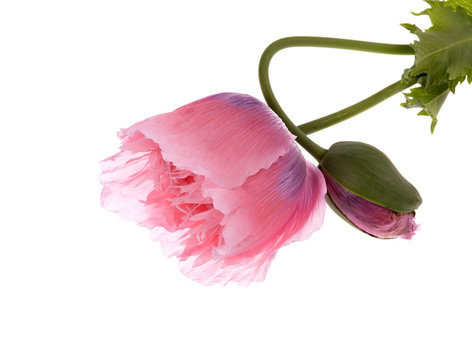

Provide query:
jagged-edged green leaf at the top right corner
left=402, top=0, right=472, bottom=132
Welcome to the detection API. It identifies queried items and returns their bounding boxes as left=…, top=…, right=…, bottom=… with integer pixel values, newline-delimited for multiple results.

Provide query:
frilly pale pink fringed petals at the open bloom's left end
left=99, top=133, right=212, bottom=231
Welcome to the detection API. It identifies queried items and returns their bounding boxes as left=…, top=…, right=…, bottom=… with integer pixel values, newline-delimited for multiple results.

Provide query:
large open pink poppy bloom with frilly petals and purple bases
left=100, top=93, right=326, bottom=285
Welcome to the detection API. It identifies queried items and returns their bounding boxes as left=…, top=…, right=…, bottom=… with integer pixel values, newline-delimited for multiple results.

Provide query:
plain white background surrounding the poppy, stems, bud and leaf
left=0, top=0, right=472, bottom=360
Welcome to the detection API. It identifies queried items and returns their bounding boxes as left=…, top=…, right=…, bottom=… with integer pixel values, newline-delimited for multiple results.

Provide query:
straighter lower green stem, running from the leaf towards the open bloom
left=298, top=78, right=417, bottom=134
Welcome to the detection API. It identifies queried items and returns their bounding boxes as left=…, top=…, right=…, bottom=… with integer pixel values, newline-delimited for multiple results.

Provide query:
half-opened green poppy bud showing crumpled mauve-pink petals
left=320, top=141, right=422, bottom=239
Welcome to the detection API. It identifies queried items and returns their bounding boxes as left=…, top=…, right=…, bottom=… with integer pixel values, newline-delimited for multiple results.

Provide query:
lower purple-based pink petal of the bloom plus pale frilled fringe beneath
left=162, top=145, right=326, bottom=285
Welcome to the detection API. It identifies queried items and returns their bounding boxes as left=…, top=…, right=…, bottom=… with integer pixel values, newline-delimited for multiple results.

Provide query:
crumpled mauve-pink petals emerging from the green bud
left=323, top=171, right=419, bottom=239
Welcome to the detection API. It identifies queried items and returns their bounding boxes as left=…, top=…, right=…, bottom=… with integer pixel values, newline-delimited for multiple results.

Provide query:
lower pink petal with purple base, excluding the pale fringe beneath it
left=204, top=144, right=326, bottom=256
